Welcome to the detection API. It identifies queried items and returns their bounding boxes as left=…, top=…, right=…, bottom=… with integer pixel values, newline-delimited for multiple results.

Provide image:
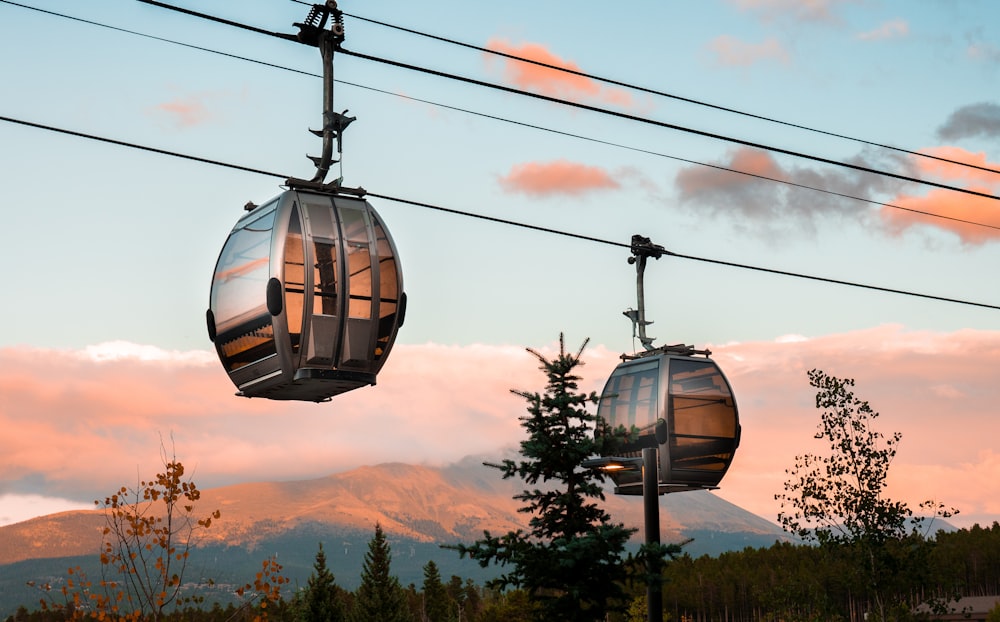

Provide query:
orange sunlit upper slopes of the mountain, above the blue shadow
left=0, top=457, right=787, bottom=565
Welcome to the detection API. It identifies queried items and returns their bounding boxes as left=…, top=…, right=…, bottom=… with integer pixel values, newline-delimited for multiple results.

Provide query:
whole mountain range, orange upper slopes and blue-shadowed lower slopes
left=0, top=457, right=789, bottom=617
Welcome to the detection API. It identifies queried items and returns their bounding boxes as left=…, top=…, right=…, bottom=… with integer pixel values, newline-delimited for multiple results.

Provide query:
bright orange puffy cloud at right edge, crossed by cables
left=881, top=147, right=1000, bottom=245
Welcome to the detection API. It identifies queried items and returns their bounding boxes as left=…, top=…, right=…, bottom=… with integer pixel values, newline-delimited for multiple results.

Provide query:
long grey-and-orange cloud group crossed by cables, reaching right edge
left=675, top=147, right=1000, bottom=245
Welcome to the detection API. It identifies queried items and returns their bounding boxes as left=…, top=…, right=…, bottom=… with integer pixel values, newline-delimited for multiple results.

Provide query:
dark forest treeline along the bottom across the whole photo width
left=7, top=522, right=1000, bottom=622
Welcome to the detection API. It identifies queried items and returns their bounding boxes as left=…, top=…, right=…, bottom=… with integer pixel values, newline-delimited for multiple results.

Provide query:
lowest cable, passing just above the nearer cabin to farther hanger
left=0, top=116, right=1000, bottom=311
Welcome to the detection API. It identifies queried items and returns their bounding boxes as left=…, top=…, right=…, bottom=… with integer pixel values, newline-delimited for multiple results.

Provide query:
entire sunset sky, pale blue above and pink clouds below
left=0, top=0, right=1000, bottom=526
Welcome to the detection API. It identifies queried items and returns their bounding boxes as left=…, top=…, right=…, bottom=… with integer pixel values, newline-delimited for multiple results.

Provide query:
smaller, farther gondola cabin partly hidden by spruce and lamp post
left=597, top=346, right=740, bottom=495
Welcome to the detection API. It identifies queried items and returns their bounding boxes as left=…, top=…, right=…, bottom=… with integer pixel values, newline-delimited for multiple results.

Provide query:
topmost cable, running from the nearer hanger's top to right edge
left=342, top=11, right=1000, bottom=174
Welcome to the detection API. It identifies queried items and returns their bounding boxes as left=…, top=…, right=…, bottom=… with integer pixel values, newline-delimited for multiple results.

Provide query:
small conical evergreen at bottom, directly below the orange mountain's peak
left=351, top=523, right=411, bottom=622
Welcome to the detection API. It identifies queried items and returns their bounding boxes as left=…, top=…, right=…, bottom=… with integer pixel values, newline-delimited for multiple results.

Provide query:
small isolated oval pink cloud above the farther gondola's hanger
left=500, top=160, right=620, bottom=196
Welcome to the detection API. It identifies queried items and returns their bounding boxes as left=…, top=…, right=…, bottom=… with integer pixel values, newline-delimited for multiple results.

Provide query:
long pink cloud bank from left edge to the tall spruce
left=0, top=344, right=556, bottom=512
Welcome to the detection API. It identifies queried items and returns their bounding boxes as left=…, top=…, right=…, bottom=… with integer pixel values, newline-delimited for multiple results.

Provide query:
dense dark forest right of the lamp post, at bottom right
left=663, top=522, right=1000, bottom=622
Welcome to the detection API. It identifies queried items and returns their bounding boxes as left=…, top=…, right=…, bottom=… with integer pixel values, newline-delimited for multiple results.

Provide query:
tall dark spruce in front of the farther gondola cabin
left=455, top=336, right=634, bottom=620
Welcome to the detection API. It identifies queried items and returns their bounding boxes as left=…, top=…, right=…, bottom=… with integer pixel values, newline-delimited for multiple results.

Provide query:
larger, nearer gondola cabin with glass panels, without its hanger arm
left=207, top=189, right=406, bottom=402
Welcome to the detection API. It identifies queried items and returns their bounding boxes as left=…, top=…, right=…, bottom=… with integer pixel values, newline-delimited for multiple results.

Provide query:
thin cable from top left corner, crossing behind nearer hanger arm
left=9, top=0, right=1000, bottom=230
